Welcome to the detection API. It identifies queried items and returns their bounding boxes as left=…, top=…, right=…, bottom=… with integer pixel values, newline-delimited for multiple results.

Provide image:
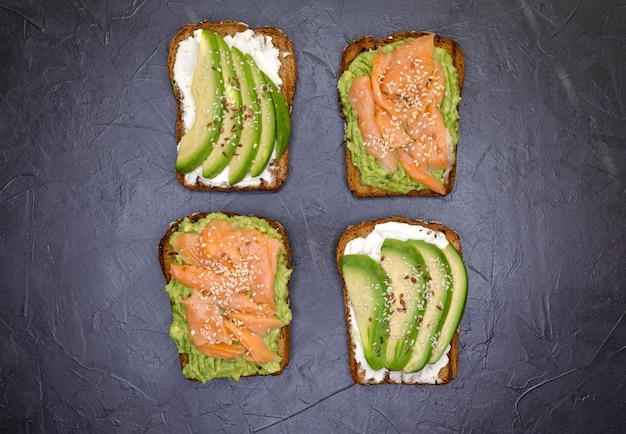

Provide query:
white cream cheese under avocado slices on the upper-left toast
left=174, top=29, right=282, bottom=187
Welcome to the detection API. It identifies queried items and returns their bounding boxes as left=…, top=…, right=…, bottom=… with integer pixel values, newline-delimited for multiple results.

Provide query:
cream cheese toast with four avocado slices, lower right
left=336, top=217, right=467, bottom=385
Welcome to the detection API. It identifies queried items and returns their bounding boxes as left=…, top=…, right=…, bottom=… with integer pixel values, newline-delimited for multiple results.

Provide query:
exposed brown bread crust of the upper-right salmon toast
left=339, top=31, right=465, bottom=198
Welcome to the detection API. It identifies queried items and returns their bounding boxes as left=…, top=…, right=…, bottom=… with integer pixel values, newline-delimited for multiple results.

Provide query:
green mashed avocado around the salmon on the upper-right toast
left=337, top=39, right=461, bottom=194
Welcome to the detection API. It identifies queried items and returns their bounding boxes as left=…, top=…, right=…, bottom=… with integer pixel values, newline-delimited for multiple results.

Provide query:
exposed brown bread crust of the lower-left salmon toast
left=158, top=211, right=291, bottom=381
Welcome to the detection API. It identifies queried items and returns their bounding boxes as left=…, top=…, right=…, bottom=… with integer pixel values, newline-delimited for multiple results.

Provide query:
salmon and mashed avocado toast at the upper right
left=338, top=32, right=465, bottom=197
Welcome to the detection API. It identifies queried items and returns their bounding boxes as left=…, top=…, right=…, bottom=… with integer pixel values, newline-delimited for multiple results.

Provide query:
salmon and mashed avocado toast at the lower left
left=159, top=213, right=291, bottom=383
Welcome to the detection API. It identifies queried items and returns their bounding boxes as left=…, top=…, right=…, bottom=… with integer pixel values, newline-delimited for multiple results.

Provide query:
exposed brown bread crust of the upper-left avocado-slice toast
left=167, top=21, right=297, bottom=191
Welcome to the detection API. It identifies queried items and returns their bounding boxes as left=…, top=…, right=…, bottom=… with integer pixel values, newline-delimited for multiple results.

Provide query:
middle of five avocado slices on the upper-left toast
left=228, top=47, right=261, bottom=185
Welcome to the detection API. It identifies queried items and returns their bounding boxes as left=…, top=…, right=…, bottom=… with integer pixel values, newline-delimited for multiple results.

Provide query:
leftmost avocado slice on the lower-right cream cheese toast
left=341, top=254, right=389, bottom=370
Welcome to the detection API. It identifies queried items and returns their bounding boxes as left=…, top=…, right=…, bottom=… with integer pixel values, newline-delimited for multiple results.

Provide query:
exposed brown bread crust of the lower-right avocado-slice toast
left=335, top=216, right=462, bottom=386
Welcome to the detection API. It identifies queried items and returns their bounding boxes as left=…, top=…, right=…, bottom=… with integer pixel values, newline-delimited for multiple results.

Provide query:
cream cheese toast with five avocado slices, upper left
left=168, top=21, right=297, bottom=191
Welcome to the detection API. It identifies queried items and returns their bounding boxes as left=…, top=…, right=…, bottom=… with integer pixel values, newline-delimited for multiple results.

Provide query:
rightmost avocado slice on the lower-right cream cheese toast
left=428, top=244, right=467, bottom=363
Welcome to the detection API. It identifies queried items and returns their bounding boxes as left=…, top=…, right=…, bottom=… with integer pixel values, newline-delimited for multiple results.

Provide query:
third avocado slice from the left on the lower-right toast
left=404, top=240, right=452, bottom=373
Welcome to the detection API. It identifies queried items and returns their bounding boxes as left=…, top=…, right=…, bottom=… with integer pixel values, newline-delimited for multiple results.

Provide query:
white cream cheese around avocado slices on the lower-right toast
left=343, top=222, right=450, bottom=384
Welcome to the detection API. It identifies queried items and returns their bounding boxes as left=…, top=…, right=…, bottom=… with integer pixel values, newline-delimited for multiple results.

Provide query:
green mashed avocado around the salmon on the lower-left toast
left=165, top=213, right=291, bottom=383
